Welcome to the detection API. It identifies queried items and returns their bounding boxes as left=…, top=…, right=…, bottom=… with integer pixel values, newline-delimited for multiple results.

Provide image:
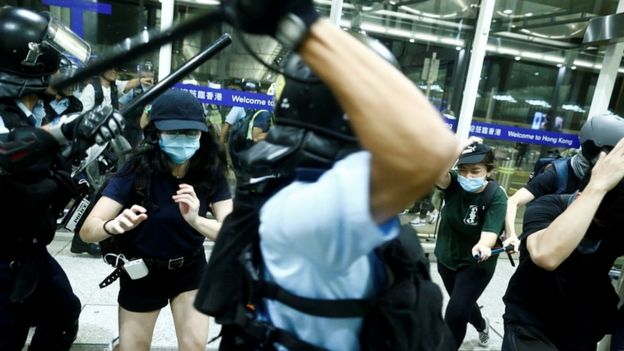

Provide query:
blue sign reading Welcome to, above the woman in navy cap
left=174, top=83, right=275, bottom=111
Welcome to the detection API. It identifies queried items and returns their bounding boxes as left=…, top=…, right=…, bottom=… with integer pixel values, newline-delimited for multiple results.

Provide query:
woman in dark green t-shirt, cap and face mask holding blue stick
left=434, top=137, right=507, bottom=349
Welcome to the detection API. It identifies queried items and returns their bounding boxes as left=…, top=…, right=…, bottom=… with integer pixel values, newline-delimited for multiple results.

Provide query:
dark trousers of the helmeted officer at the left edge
left=0, top=249, right=81, bottom=351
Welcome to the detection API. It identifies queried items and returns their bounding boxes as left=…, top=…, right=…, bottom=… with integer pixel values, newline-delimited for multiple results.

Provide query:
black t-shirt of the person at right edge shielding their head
left=503, top=195, right=624, bottom=350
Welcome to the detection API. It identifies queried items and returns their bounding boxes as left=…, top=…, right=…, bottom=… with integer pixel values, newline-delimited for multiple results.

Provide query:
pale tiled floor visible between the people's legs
left=29, top=233, right=513, bottom=351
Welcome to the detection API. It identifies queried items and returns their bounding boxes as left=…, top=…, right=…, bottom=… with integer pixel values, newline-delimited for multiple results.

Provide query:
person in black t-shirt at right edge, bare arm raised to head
left=502, top=140, right=624, bottom=351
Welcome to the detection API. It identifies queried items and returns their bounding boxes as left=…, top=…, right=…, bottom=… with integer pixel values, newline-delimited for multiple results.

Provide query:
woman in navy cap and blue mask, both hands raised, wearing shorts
left=80, top=89, right=232, bottom=351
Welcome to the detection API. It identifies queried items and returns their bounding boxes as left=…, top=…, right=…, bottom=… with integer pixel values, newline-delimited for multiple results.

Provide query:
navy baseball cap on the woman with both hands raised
left=150, top=89, right=208, bottom=132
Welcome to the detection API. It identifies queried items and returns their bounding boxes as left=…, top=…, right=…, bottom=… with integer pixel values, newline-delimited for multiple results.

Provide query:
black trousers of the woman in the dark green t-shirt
left=438, top=263, right=494, bottom=349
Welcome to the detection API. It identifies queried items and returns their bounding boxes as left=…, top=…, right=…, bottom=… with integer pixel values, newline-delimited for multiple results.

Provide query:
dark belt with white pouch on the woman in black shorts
left=100, top=246, right=204, bottom=288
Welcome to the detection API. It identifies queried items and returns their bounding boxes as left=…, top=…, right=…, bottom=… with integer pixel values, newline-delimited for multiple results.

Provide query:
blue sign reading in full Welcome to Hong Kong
left=445, top=119, right=581, bottom=149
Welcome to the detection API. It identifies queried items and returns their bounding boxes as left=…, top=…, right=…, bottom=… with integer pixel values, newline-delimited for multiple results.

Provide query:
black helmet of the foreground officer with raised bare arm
left=275, top=32, right=399, bottom=141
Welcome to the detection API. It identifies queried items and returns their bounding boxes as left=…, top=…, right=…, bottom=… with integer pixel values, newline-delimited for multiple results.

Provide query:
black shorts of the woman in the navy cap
left=117, top=250, right=207, bottom=312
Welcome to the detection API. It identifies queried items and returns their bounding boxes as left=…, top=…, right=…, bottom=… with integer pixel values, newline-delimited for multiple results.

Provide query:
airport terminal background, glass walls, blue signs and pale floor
left=6, top=0, right=624, bottom=350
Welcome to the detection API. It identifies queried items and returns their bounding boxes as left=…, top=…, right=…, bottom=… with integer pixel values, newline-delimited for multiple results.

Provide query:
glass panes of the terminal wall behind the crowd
left=5, top=0, right=624, bottom=192
